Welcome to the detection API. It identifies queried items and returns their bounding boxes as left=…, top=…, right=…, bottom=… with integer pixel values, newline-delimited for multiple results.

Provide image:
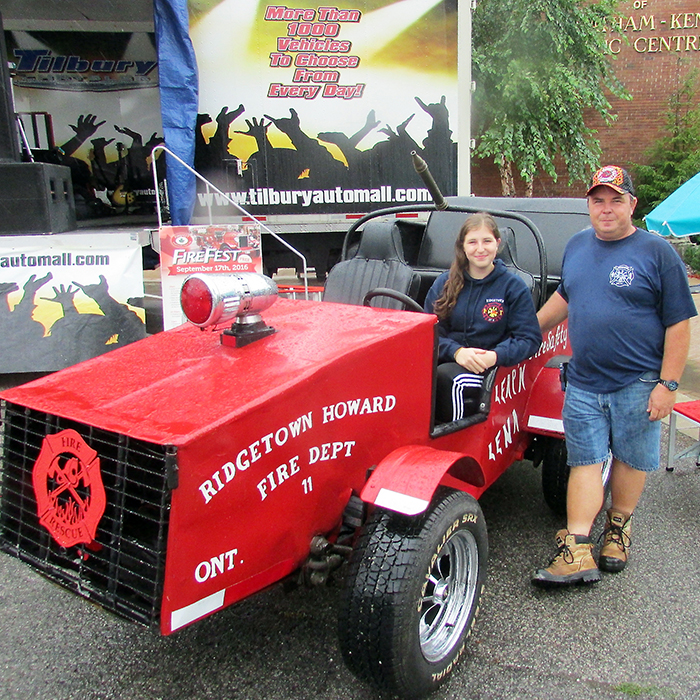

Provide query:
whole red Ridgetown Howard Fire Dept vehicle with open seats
left=0, top=193, right=587, bottom=698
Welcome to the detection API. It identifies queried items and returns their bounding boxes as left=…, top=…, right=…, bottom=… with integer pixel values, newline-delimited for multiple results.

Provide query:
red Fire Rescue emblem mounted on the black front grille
left=32, top=430, right=107, bottom=547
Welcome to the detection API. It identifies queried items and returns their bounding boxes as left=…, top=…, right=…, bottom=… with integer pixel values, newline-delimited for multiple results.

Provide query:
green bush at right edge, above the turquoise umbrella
left=630, top=68, right=700, bottom=219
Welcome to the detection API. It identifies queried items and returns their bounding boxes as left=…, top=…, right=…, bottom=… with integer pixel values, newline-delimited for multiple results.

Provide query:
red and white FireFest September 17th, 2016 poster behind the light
left=160, top=224, right=262, bottom=330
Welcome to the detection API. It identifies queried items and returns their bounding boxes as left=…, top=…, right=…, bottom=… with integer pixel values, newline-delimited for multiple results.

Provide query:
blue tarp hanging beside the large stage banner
left=153, top=0, right=198, bottom=226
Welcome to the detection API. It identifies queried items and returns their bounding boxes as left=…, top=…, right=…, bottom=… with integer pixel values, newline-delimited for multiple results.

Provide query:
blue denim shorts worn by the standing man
left=562, top=372, right=661, bottom=472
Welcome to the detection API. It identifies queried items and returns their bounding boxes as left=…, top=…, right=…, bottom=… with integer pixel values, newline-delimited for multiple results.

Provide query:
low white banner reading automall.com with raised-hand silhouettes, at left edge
left=0, top=233, right=146, bottom=373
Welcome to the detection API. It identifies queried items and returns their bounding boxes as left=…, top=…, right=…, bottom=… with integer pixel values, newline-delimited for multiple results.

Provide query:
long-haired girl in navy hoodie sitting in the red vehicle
left=425, top=212, right=542, bottom=423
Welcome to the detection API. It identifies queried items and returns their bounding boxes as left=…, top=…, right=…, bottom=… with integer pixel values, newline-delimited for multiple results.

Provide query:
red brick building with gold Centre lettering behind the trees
left=472, top=0, right=700, bottom=196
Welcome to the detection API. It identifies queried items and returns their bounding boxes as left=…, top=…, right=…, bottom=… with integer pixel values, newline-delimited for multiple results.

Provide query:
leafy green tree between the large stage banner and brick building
left=472, top=0, right=629, bottom=196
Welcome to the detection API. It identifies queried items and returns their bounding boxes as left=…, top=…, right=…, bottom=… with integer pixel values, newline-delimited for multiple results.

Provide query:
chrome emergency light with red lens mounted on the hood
left=180, top=272, right=277, bottom=347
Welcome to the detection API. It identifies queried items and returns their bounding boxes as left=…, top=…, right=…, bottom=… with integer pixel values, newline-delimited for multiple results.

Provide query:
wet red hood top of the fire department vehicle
left=0, top=299, right=435, bottom=445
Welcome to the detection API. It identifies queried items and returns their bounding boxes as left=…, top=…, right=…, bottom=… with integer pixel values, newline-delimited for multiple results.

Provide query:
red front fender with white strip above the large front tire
left=360, top=445, right=485, bottom=515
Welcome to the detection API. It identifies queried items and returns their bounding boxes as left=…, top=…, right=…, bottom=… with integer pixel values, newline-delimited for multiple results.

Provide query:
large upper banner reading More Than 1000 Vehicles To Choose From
left=189, top=0, right=457, bottom=215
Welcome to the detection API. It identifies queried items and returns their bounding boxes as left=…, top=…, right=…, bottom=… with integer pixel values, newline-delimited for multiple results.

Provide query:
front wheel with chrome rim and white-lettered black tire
left=339, top=490, right=488, bottom=698
